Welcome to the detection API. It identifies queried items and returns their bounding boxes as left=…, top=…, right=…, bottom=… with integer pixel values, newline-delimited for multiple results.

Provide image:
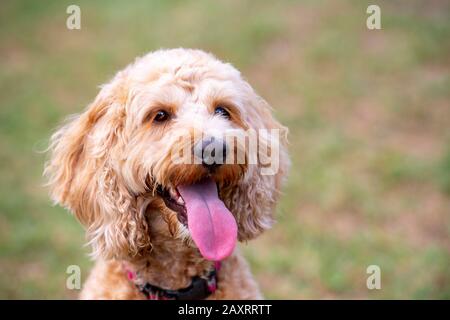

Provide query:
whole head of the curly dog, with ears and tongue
left=45, top=49, right=288, bottom=260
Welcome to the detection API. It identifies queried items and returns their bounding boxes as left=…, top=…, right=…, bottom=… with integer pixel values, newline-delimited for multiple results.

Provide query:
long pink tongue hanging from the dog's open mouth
left=178, top=179, right=237, bottom=261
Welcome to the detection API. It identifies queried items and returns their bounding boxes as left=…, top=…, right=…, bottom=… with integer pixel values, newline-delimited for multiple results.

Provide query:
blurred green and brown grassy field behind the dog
left=0, top=0, right=450, bottom=299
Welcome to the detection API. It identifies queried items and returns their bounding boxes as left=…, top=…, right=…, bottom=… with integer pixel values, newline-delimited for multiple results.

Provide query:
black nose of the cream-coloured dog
left=196, top=137, right=227, bottom=170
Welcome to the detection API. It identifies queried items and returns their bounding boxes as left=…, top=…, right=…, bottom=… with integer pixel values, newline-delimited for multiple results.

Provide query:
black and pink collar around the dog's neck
left=127, top=262, right=220, bottom=300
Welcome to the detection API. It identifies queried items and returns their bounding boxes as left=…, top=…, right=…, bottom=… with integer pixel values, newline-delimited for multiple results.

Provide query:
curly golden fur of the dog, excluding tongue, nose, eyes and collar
left=45, top=49, right=288, bottom=299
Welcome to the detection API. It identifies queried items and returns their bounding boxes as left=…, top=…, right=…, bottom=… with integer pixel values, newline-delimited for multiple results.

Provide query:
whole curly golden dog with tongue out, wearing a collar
left=45, top=49, right=288, bottom=299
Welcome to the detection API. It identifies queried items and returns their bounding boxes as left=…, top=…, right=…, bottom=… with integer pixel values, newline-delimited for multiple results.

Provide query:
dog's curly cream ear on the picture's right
left=228, top=85, right=290, bottom=241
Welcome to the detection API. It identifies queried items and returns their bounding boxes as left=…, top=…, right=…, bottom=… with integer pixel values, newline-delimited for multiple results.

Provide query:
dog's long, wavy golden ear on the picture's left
left=44, top=85, right=150, bottom=258
